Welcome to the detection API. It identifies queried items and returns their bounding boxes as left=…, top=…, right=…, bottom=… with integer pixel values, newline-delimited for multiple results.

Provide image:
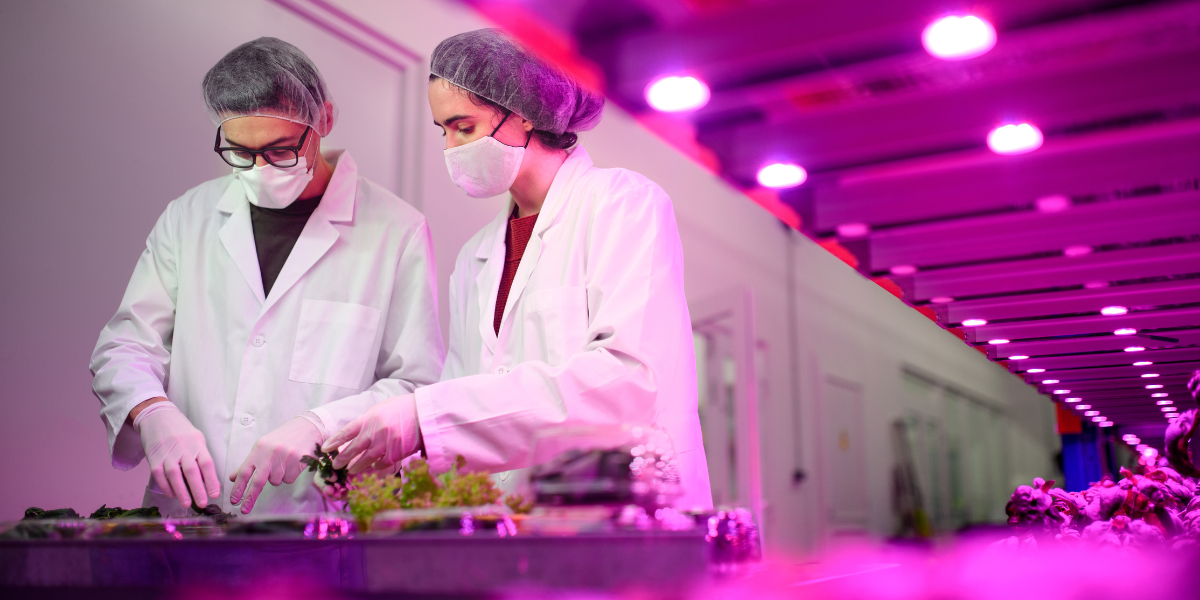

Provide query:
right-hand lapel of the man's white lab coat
left=263, top=150, right=359, bottom=312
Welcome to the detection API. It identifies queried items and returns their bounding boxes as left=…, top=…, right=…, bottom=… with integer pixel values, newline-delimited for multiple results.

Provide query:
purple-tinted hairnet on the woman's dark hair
left=430, top=29, right=604, bottom=134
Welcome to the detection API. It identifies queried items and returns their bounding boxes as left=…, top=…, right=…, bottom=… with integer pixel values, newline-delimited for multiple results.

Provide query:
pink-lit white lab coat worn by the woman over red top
left=416, top=148, right=713, bottom=508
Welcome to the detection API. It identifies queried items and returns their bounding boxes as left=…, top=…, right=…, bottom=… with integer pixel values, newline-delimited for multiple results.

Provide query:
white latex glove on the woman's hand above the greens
left=322, top=394, right=421, bottom=475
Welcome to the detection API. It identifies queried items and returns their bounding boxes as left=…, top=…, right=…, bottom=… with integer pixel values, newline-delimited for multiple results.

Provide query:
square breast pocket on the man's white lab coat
left=288, top=300, right=380, bottom=390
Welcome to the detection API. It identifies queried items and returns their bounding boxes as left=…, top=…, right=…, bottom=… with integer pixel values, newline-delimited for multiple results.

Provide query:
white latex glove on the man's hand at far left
left=133, top=402, right=221, bottom=509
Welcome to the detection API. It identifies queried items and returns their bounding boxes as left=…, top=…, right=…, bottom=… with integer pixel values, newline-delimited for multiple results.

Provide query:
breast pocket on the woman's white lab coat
left=524, top=287, right=588, bottom=366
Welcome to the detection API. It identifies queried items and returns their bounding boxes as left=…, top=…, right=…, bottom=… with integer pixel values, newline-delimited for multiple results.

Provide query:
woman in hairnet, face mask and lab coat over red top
left=325, top=30, right=712, bottom=508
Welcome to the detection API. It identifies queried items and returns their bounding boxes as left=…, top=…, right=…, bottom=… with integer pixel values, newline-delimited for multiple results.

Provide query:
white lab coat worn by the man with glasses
left=91, top=151, right=444, bottom=515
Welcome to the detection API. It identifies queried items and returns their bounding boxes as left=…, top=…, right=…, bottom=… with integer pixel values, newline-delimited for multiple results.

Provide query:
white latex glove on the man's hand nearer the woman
left=229, top=416, right=325, bottom=515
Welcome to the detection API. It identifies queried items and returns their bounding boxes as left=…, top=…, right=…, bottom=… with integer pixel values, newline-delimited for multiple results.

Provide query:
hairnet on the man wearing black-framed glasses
left=204, top=37, right=337, bottom=137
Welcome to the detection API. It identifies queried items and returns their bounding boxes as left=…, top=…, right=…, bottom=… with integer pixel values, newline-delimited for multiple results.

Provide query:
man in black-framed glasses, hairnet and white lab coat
left=91, top=37, right=444, bottom=516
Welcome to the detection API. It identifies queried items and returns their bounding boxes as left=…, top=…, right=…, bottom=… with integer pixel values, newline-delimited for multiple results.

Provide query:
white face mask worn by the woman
left=445, top=113, right=533, bottom=198
